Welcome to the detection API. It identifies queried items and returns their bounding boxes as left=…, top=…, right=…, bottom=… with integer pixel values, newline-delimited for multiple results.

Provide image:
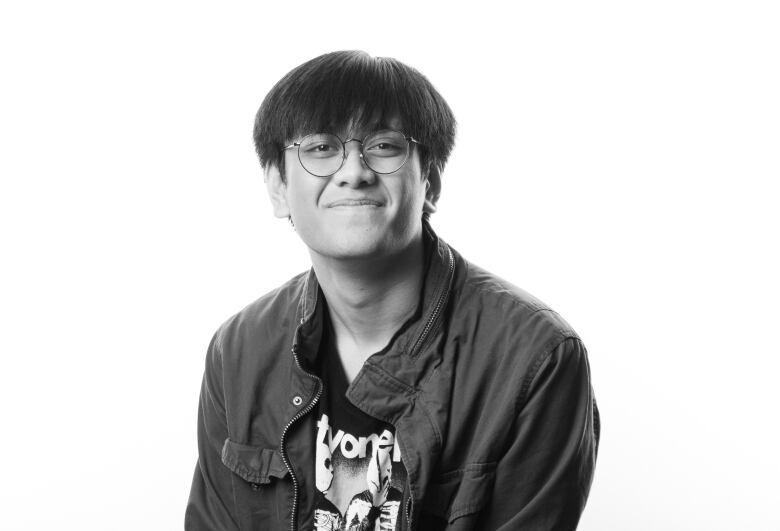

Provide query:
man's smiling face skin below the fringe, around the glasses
left=269, top=120, right=426, bottom=259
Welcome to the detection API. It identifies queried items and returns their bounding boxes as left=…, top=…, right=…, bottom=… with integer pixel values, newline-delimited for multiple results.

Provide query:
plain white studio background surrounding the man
left=0, top=0, right=780, bottom=531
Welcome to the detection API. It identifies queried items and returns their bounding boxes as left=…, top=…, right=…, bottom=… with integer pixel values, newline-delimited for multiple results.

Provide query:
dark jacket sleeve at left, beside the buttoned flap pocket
left=184, top=332, right=238, bottom=531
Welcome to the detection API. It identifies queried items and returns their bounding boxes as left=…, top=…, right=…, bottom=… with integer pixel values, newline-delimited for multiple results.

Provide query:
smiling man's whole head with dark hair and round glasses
left=254, top=51, right=455, bottom=262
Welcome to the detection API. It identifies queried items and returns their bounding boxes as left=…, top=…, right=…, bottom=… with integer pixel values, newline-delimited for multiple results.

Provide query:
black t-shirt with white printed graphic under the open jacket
left=314, top=319, right=406, bottom=531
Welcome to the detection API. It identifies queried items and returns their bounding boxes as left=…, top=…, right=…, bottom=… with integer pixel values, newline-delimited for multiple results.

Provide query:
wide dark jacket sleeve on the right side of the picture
left=487, top=338, right=600, bottom=531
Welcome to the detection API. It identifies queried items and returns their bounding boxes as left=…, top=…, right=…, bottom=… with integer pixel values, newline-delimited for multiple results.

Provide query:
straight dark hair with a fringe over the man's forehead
left=254, top=50, right=456, bottom=178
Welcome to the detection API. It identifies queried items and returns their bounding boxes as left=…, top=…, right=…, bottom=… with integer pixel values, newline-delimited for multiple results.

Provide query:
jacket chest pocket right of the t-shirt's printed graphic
left=421, top=462, right=496, bottom=524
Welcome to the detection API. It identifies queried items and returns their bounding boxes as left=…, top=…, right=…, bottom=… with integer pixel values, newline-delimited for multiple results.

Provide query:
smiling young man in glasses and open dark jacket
left=185, top=52, right=599, bottom=530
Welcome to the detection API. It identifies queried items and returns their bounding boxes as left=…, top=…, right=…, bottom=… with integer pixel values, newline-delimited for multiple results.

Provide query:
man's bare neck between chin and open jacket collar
left=311, top=234, right=424, bottom=381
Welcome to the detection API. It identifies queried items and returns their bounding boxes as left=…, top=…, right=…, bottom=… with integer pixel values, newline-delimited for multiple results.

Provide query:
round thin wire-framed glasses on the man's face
left=282, top=129, right=420, bottom=177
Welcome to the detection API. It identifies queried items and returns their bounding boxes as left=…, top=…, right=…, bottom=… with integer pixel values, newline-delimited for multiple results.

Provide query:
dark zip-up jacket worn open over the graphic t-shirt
left=185, top=225, right=599, bottom=531
